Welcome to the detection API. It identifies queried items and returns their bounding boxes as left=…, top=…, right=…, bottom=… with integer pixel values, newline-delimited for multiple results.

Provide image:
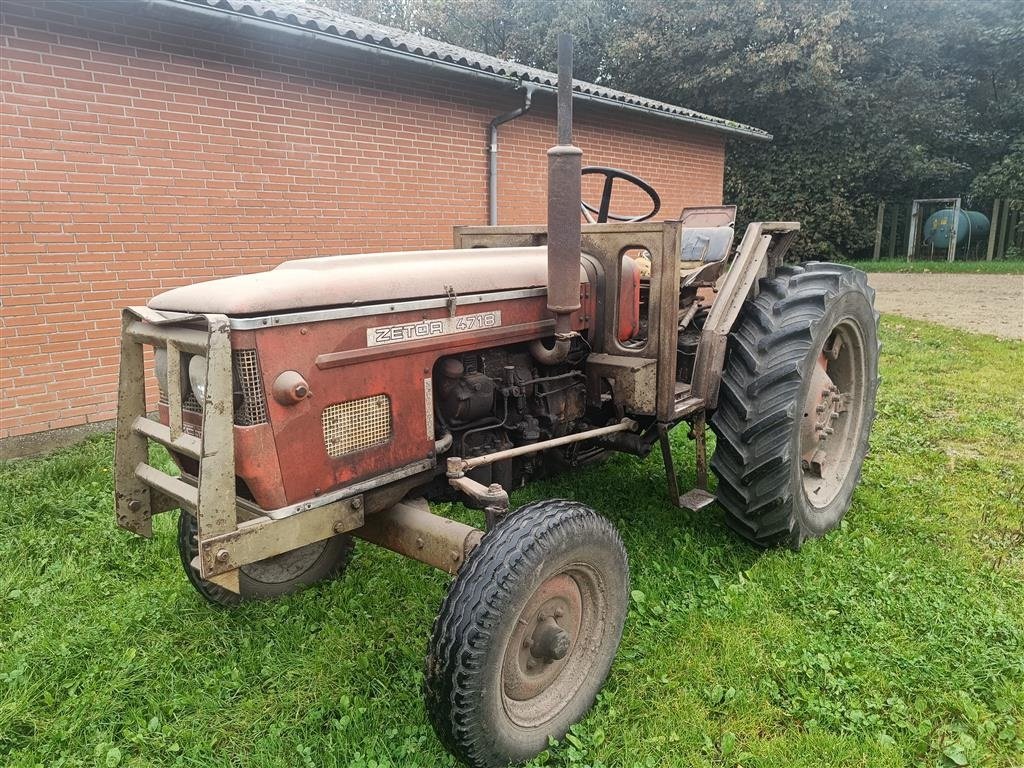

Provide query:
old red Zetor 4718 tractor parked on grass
left=116, top=37, right=879, bottom=766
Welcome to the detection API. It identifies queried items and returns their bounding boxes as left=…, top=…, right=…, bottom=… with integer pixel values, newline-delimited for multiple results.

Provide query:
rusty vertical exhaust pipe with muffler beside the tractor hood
left=530, top=33, right=583, bottom=366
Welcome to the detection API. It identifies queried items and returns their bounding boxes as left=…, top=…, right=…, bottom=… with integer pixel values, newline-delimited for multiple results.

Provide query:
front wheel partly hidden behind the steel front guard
left=178, top=510, right=354, bottom=606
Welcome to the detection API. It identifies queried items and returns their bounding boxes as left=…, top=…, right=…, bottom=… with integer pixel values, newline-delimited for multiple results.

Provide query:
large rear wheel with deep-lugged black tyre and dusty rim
left=711, top=262, right=879, bottom=549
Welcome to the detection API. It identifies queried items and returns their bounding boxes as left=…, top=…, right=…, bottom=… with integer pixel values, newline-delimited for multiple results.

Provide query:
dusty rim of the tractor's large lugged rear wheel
left=800, top=319, right=866, bottom=509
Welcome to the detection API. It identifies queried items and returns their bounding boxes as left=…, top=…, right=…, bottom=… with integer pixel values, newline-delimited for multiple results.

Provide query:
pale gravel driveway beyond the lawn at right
left=867, top=272, right=1024, bottom=339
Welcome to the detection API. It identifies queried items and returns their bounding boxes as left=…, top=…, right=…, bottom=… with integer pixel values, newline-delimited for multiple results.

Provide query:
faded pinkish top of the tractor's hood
left=148, top=246, right=587, bottom=315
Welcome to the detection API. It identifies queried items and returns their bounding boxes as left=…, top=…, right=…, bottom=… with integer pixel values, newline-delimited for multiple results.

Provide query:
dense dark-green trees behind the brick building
left=322, top=0, right=1024, bottom=258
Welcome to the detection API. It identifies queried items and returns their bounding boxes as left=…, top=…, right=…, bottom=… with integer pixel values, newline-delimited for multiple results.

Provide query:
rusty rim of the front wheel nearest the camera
left=501, top=563, right=608, bottom=728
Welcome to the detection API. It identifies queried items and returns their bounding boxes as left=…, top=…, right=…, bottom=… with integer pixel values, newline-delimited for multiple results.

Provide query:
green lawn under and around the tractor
left=0, top=317, right=1024, bottom=768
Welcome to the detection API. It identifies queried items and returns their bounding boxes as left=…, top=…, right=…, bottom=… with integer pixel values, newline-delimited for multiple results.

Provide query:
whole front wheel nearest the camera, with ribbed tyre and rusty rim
left=424, top=500, right=629, bottom=768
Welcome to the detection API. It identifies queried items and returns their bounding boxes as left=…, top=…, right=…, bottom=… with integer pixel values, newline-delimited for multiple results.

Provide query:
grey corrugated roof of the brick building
left=158, top=0, right=771, bottom=139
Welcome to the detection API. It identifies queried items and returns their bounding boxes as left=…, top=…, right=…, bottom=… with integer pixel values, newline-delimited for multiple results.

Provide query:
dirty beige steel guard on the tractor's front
left=114, top=307, right=364, bottom=592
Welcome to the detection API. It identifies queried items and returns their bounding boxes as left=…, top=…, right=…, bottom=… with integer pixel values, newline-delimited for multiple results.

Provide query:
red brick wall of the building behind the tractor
left=0, top=0, right=724, bottom=438
